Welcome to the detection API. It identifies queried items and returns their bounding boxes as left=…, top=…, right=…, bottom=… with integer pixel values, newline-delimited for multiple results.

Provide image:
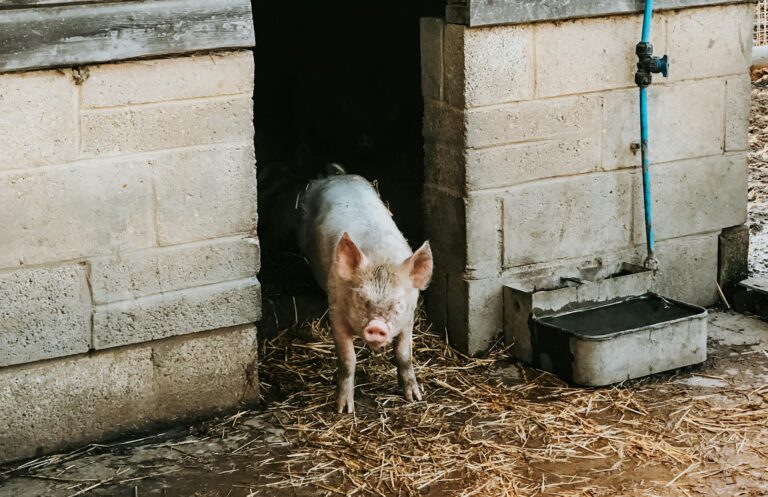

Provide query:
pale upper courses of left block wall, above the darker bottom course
left=0, top=51, right=261, bottom=370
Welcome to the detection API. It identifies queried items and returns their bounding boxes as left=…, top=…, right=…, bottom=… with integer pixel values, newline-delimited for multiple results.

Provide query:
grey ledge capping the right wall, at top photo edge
left=445, top=0, right=754, bottom=26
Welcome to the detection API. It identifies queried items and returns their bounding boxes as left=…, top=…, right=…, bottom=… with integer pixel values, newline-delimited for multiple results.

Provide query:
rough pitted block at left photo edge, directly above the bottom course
left=0, top=264, right=91, bottom=367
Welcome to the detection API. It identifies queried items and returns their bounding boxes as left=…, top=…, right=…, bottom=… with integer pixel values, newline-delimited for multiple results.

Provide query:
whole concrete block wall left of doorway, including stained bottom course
left=0, top=50, right=261, bottom=461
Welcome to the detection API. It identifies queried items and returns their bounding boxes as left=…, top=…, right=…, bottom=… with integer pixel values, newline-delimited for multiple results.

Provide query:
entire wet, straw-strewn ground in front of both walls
left=0, top=312, right=768, bottom=497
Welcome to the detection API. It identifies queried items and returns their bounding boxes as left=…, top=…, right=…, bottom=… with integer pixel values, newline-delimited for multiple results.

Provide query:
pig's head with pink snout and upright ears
left=332, top=233, right=432, bottom=351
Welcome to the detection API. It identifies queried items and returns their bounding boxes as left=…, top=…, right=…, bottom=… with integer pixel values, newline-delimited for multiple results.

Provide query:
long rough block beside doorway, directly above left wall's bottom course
left=93, top=278, right=261, bottom=350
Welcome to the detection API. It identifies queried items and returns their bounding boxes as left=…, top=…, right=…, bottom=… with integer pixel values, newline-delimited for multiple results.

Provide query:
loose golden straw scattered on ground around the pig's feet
left=244, top=310, right=768, bottom=497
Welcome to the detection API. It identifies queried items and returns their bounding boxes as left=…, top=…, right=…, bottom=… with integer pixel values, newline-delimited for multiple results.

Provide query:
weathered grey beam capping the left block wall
left=0, top=0, right=254, bottom=72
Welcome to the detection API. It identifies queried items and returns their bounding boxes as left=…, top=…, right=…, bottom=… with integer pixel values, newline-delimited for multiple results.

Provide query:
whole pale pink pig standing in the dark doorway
left=297, top=165, right=433, bottom=413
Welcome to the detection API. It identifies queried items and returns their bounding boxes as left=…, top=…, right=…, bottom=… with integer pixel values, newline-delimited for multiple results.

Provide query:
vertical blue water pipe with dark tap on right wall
left=635, top=0, right=669, bottom=270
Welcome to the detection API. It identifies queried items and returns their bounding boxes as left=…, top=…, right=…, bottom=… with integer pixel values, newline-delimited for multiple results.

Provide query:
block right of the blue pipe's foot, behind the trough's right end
left=654, top=233, right=719, bottom=306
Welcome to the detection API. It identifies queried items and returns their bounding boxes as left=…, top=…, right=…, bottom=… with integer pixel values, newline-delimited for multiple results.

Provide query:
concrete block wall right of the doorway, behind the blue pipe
left=421, top=4, right=753, bottom=354
